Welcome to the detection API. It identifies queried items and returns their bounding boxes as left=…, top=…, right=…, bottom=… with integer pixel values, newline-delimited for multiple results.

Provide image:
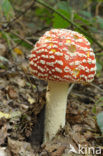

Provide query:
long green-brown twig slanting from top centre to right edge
left=36, top=0, right=103, bottom=49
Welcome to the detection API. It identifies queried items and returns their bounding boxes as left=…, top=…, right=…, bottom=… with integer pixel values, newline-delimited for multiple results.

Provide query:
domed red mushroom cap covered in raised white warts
left=30, top=29, right=96, bottom=82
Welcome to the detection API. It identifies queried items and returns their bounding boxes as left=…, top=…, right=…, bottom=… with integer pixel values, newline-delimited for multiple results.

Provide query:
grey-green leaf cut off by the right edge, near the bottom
left=96, top=112, right=103, bottom=135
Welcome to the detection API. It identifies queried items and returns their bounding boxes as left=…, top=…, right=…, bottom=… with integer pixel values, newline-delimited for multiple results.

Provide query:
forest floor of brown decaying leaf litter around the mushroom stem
left=0, top=8, right=103, bottom=156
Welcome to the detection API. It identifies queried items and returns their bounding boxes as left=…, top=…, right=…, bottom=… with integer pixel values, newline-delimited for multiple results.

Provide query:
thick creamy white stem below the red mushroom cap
left=44, top=81, right=68, bottom=142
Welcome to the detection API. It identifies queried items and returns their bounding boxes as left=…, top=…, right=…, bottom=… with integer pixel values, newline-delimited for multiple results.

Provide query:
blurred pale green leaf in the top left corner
left=0, top=0, right=15, bottom=21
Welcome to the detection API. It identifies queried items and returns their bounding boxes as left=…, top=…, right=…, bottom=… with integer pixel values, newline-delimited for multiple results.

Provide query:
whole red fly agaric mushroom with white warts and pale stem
left=30, top=29, right=96, bottom=142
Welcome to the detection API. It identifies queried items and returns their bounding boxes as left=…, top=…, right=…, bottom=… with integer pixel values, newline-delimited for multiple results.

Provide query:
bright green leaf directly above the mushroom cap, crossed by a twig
left=53, top=9, right=70, bottom=28
